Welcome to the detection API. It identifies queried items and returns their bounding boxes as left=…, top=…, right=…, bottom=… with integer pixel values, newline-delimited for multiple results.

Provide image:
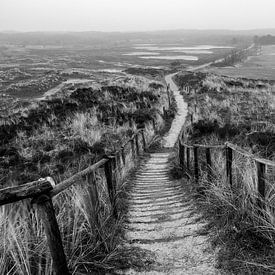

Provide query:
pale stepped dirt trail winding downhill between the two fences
left=120, top=75, right=219, bottom=274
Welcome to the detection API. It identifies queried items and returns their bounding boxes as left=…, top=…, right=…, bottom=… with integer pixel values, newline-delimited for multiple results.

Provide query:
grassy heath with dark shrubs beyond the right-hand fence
left=177, top=73, right=275, bottom=159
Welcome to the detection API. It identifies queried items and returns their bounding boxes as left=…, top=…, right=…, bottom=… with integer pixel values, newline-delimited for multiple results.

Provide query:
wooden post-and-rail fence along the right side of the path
left=178, top=131, right=275, bottom=209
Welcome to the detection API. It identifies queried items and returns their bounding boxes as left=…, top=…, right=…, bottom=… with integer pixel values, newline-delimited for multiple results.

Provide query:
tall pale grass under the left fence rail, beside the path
left=0, top=125, right=154, bottom=275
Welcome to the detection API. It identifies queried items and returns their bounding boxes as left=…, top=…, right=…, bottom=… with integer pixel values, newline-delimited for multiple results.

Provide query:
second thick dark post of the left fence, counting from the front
left=104, top=156, right=118, bottom=218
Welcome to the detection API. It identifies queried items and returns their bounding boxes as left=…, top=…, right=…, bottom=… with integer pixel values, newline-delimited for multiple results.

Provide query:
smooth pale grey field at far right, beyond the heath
left=205, top=45, right=275, bottom=81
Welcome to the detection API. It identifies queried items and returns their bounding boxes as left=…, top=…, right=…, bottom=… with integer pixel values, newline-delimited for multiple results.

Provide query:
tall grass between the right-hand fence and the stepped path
left=180, top=137, right=275, bottom=274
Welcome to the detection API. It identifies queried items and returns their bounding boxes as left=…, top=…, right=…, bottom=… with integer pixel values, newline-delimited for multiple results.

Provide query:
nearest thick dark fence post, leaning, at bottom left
left=34, top=195, right=70, bottom=275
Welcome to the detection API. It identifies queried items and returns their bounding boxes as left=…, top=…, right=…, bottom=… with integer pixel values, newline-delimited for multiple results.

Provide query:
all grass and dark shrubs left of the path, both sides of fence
left=0, top=76, right=176, bottom=274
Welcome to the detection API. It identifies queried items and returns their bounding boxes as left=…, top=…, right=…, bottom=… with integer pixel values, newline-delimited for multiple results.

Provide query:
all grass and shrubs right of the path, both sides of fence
left=176, top=73, right=275, bottom=274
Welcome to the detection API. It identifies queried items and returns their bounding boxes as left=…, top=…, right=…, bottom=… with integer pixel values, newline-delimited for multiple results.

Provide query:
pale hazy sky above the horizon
left=0, top=0, right=275, bottom=31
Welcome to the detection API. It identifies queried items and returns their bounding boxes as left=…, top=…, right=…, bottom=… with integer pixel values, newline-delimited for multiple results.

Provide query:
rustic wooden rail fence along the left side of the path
left=0, top=125, right=156, bottom=275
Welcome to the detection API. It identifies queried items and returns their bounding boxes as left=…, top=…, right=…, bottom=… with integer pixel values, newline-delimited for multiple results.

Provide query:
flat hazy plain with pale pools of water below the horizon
left=0, top=33, right=246, bottom=99
